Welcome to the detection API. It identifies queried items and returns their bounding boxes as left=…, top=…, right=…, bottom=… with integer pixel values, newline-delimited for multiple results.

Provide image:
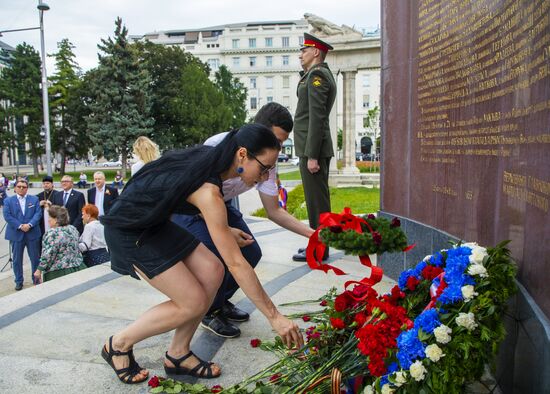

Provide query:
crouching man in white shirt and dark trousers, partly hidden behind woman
left=172, top=102, right=314, bottom=338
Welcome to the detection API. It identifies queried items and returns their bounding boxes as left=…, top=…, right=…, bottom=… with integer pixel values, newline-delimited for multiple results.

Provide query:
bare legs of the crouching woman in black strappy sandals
left=106, top=244, right=223, bottom=381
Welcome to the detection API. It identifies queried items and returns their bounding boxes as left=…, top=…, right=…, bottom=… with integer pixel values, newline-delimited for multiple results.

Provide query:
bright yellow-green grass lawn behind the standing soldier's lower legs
left=252, top=185, right=380, bottom=220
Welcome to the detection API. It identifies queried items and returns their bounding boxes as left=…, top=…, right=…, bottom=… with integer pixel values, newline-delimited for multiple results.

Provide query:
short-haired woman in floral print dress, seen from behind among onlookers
left=34, top=205, right=86, bottom=282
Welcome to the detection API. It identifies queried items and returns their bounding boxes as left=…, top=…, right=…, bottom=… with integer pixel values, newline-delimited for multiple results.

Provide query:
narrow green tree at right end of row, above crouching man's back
left=214, top=65, right=247, bottom=128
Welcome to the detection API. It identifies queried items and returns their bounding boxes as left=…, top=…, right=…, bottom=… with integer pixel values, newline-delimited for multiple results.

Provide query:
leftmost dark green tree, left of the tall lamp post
left=1, top=43, right=44, bottom=176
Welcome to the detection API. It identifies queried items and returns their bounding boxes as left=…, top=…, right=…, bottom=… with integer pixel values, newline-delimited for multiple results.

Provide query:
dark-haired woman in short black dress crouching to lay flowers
left=100, top=124, right=303, bottom=383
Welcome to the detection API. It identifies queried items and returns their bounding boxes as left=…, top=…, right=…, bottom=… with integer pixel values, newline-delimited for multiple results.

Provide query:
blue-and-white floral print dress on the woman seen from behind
left=38, top=225, right=85, bottom=281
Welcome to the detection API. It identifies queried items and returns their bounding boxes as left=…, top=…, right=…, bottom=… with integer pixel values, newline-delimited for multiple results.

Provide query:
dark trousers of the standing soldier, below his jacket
left=300, top=157, right=330, bottom=229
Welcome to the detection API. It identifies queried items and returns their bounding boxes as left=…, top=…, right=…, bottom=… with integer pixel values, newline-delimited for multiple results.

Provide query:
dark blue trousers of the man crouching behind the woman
left=172, top=202, right=262, bottom=314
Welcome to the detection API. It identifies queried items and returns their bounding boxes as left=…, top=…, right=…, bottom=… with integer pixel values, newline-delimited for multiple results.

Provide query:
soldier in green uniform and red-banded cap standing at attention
left=292, top=33, right=336, bottom=261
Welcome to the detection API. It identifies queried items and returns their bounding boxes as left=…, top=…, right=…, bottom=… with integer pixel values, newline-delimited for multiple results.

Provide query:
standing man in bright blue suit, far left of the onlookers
left=4, top=179, right=42, bottom=291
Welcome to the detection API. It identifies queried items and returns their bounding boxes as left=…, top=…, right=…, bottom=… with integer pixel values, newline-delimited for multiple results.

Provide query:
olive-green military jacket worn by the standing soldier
left=294, top=63, right=336, bottom=159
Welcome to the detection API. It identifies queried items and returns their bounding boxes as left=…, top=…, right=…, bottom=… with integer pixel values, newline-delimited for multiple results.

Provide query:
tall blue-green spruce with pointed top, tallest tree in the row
left=87, top=18, right=154, bottom=176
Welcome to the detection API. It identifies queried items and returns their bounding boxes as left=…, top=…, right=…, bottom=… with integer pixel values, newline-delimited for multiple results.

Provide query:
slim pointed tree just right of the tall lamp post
left=48, top=38, right=83, bottom=174
